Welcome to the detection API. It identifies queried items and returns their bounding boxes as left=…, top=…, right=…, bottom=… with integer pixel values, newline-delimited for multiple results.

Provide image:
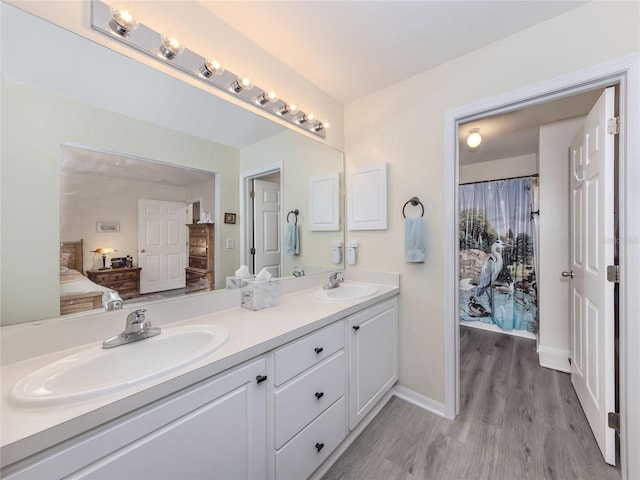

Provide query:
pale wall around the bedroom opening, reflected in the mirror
left=0, top=80, right=239, bottom=325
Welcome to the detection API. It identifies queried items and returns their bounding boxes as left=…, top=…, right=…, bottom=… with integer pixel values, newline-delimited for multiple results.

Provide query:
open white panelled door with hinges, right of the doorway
left=570, top=87, right=615, bottom=465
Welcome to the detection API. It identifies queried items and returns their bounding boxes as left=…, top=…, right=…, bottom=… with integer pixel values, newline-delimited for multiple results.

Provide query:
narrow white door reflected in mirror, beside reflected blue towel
left=253, top=179, right=282, bottom=277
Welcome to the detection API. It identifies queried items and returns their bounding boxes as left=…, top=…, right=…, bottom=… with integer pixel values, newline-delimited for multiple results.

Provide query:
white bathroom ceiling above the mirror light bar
left=199, top=0, right=586, bottom=104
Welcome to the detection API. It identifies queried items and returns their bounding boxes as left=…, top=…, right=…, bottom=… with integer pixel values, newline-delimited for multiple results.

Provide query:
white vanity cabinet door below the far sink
left=348, top=298, right=398, bottom=430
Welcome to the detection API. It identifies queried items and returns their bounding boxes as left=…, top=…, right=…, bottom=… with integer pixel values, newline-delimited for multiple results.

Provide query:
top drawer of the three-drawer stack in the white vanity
left=274, top=321, right=344, bottom=386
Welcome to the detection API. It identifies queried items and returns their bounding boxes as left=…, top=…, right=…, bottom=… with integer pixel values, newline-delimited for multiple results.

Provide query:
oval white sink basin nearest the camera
left=10, top=325, right=229, bottom=407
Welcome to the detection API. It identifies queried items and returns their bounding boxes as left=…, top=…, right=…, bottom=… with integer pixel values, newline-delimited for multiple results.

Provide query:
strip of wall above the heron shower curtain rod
left=459, top=154, right=538, bottom=183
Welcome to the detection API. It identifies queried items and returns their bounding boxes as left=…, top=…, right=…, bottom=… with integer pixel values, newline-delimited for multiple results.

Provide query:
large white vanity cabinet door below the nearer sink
left=9, top=358, right=267, bottom=480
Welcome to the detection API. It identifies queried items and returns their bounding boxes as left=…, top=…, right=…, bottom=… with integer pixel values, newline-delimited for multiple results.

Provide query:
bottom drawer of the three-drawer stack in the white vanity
left=276, top=397, right=347, bottom=480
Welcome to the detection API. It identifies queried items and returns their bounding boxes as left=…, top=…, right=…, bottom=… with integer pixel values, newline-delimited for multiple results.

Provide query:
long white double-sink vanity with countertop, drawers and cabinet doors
left=1, top=271, right=399, bottom=479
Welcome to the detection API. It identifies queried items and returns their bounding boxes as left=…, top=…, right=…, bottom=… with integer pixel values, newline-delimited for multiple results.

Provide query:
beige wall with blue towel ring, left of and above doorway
left=345, top=2, right=640, bottom=402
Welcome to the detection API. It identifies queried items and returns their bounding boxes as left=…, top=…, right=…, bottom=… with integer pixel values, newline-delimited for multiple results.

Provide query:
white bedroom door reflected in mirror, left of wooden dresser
left=138, top=198, right=187, bottom=293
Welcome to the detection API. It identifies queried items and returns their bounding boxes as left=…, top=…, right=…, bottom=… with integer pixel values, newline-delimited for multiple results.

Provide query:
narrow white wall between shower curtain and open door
left=537, top=118, right=582, bottom=372
